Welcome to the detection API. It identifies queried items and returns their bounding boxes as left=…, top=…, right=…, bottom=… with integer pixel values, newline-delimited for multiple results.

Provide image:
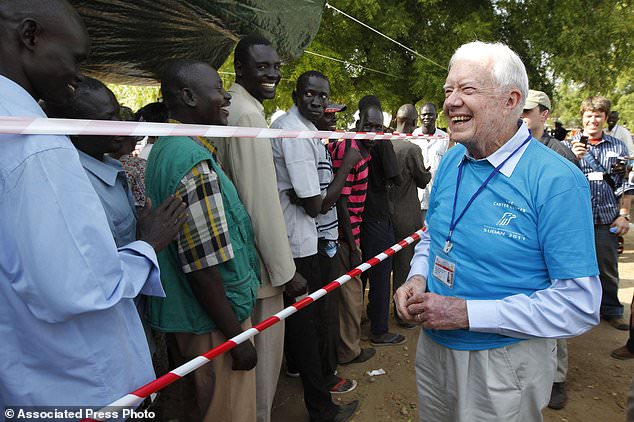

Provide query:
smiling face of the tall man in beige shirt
left=235, top=45, right=282, bottom=102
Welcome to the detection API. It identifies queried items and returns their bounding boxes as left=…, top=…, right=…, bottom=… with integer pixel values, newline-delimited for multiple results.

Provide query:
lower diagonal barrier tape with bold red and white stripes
left=82, top=227, right=426, bottom=422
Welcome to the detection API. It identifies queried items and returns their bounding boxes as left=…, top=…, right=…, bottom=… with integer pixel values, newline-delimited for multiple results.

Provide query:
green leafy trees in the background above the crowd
left=106, top=0, right=634, bottom=128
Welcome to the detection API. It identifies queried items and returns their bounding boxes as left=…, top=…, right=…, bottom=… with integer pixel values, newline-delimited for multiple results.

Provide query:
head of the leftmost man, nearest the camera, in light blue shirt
left=0, top=0, right=89, bottom=102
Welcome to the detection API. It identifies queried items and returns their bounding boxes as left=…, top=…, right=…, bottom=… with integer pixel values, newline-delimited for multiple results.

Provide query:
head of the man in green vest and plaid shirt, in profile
left=161, top=60, right=231, bottom=125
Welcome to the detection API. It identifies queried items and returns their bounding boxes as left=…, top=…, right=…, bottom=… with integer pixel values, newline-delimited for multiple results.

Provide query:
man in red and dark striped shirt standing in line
left=328, top=97, right=383, bottom=364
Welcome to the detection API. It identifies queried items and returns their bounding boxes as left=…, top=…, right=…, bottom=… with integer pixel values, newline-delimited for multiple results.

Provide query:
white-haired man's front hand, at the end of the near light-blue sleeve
left=406, top=293, right=469, bottom=330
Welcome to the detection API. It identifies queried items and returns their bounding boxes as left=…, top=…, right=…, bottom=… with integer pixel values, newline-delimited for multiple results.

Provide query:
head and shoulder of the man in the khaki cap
left=522, top=89, right=577, bottom=164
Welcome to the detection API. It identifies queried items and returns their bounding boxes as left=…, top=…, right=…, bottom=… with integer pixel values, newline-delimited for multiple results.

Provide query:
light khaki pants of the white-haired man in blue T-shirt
left=416, top=331, right=557, bottom=422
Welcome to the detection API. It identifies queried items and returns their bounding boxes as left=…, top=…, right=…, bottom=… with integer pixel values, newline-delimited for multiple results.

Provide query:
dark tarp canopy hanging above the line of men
left=70, top=0, right=325, bottom=85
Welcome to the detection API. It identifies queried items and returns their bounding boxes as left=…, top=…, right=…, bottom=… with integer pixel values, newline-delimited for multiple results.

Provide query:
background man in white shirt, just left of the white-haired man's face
left=411, top=103, right=449, bottom=219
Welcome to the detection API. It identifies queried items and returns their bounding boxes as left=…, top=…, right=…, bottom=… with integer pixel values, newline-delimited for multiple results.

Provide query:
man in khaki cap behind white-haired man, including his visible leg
left=521, top=89, right=577, bottom=409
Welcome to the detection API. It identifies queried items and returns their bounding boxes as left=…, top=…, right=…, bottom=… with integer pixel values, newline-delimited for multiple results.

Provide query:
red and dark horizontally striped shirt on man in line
left=328, top=139, right=370, bottom=246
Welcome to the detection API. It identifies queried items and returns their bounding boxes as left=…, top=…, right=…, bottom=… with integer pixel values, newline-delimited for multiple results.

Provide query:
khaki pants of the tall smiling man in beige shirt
left=251, top=294, right=284, bottom=422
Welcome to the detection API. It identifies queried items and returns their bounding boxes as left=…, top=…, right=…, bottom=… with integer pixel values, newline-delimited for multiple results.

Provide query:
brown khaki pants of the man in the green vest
left=167, top=318, right=255, bottom=422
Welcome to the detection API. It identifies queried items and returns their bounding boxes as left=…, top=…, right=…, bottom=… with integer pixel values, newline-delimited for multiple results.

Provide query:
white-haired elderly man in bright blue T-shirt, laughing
left=395, top=42, right=601, bottom=422
